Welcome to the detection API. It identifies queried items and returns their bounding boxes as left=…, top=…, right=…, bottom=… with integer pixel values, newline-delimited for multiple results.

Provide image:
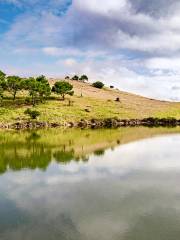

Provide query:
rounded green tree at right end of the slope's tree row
left=52, top=81, right=74, bottom=100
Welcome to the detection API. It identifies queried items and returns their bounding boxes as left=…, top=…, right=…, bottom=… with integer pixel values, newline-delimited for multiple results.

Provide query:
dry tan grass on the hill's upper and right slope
left=50, top=80, right=180, bottom=118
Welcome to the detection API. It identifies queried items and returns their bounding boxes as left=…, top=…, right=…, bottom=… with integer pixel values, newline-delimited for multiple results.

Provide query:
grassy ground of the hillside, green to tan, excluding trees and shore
left=0, top=80, right=180, bottom=123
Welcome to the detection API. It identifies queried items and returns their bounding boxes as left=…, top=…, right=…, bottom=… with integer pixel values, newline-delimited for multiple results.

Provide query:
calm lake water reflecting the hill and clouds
left=0, top=128, right=180, bottom=240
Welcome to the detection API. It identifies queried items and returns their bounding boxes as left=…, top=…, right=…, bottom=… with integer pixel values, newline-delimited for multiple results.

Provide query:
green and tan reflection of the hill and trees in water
left=0, top=128, right=180, bottom=174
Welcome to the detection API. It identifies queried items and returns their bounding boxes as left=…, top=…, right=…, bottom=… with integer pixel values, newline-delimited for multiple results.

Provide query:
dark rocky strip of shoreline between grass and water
left=0, top=118, right=180, bottom=130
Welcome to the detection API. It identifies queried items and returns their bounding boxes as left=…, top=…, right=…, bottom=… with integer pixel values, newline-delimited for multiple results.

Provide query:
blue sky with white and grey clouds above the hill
left=0, top=0, right=180, bottom=101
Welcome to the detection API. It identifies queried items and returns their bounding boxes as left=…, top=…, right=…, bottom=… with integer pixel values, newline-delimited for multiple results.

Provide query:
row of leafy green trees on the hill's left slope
left=0, top=71, right=74, bottom=106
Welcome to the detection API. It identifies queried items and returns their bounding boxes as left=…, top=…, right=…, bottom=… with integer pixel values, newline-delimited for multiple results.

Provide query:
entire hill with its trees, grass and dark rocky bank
left=0, top=71, right=180, bottom=129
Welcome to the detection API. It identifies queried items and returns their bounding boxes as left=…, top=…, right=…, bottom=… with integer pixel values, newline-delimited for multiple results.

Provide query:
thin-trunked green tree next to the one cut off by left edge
left=7, top=76, right=22, bottom=101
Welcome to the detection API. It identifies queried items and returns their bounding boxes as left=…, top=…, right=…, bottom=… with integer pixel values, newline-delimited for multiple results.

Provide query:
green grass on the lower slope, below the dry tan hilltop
left=0, top=94, right=135, bottom=123
